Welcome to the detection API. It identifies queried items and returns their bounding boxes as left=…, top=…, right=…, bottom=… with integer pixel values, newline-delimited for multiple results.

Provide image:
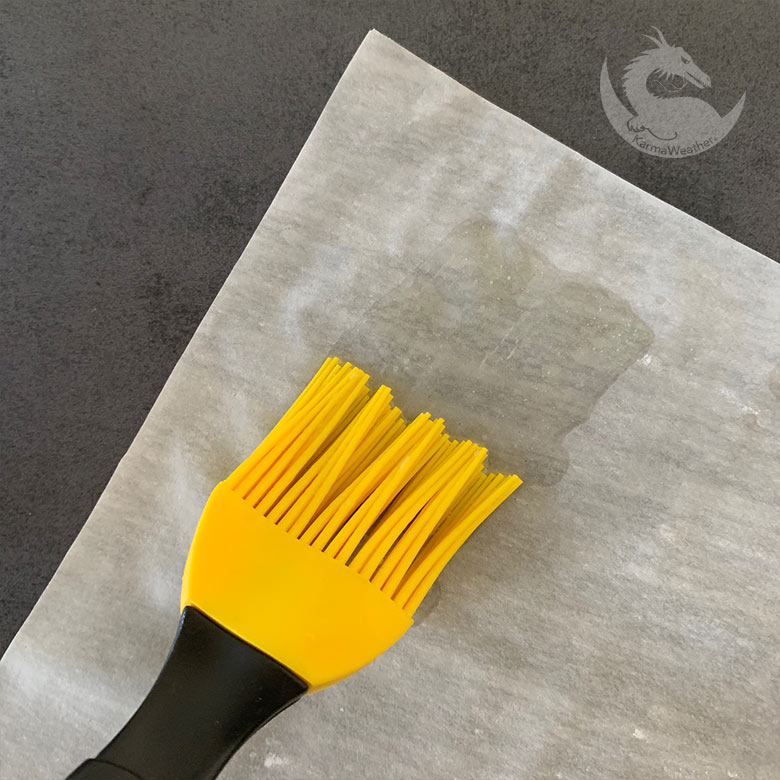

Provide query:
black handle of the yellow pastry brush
left=67, top=607, right=307, bottom=780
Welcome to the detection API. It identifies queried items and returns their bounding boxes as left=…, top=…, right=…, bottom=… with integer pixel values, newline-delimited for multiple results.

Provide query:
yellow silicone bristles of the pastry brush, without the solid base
left=226, top=358, right=521, bottom=615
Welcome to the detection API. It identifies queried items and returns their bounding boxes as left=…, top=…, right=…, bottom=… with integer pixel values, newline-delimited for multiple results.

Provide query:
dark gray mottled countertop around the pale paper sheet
left=0, top=0, right=780, bottom=650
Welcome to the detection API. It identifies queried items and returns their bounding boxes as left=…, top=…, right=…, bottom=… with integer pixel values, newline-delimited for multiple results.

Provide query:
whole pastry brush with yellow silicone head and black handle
left=65, top=358, right=521, bottom=780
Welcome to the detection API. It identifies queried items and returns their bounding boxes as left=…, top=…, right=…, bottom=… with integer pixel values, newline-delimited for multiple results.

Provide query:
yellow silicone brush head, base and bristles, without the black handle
left=181, top=358, right=521, bottom=690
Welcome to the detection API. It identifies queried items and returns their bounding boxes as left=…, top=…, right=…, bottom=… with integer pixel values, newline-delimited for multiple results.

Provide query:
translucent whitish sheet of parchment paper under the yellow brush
left=0, top=33, right=780, bottom=780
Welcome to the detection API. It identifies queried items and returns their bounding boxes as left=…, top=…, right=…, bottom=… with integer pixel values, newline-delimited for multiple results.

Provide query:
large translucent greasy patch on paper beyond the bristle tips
left=334, top=220, right=653, bottom=485
